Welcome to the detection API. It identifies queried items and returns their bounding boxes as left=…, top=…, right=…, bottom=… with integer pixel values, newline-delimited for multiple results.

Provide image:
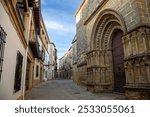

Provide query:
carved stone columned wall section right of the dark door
left=124, top=26, right=150, bottom=99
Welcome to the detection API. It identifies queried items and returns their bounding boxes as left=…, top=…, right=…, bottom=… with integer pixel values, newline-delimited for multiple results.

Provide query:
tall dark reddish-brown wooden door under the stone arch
left=112, top=29, right=126, bottom=93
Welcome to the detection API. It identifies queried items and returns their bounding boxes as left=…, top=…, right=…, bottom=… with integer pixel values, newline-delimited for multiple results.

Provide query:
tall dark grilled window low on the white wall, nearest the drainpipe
left=14, top=51, right=23, bottom=93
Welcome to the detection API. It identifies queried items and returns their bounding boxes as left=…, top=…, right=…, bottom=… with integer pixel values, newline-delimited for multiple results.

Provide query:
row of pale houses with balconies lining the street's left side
left=0, top=0, right=56, bottom=100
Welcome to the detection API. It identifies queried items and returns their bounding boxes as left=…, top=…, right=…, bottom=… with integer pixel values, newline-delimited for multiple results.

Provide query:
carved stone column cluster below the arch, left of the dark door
left=87, top=50, right=112, bottom=92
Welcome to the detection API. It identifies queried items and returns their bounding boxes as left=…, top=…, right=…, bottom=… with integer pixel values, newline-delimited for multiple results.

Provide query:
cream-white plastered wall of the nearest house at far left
left=0, top=0, right=31, bottom=99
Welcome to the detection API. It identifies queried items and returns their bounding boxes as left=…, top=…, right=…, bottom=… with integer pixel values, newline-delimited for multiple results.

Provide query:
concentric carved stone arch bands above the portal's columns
left=91, top=9, right=126, bottom=50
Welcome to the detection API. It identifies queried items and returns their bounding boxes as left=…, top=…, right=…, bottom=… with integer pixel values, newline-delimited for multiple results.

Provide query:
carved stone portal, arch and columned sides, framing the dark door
left=87, top=10, right=150, bottom=99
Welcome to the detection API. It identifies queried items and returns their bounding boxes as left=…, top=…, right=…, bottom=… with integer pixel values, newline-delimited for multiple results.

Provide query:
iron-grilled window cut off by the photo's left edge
left=0, top=25, right=6, bottom=80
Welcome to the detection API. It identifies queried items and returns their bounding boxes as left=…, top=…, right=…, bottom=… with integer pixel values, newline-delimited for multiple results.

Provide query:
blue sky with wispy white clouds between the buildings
left=41, top=0, right=82, bottom=58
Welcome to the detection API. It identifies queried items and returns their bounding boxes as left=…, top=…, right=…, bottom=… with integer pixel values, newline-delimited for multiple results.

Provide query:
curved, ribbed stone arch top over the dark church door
left=90, top=9, right=127, bottom=50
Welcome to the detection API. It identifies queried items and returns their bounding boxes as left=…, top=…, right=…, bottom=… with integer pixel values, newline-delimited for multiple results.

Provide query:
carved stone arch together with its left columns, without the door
left=87, top=9, right=126, bottom=92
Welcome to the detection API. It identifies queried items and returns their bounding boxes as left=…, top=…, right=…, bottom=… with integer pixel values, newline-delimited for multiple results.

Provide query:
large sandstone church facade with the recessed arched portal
left=73, top=0, right=150, bottom=99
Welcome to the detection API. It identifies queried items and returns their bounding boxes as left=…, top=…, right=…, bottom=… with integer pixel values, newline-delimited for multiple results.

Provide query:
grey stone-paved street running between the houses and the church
left=25, top=80, right=125, bottom=100
